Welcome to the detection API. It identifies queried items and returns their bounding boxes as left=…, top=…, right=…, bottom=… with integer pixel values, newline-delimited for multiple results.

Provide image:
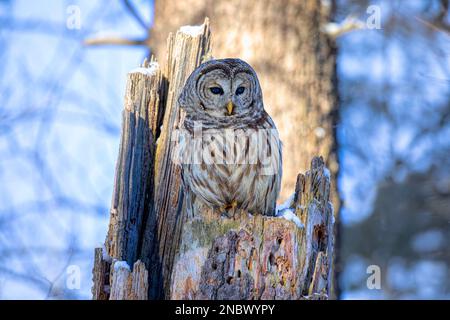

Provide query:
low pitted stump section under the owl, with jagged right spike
left=170, top=158, right=334, bottom=299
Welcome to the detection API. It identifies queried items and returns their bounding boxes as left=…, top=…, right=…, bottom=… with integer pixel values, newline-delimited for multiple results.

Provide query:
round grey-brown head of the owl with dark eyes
left=178, top=59, right=264, bottom=121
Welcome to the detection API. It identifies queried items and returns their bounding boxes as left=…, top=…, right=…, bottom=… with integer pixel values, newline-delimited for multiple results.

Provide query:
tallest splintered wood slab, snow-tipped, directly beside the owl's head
left=143, top=19, right=211, bottom=299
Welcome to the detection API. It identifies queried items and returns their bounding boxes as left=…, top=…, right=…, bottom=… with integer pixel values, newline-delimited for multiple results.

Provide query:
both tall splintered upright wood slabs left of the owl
left=93, top=19, right=210, bottom=299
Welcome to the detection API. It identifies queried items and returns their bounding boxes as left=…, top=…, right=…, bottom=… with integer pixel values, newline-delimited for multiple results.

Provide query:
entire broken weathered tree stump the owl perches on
left=92, top=19, right=333, bottom=299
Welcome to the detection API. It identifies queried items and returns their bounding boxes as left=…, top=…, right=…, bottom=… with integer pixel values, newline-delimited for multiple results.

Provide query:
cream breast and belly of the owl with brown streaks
left=179, top=122, right=281, bottom=212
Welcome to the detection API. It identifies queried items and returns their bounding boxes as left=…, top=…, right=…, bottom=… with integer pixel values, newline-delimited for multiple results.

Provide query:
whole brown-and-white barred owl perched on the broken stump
left=178, top=59, right=282, bottom=216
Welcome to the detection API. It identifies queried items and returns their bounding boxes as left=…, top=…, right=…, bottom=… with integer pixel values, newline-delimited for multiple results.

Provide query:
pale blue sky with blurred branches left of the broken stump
left=0, top=1, right=150, bottom=298
